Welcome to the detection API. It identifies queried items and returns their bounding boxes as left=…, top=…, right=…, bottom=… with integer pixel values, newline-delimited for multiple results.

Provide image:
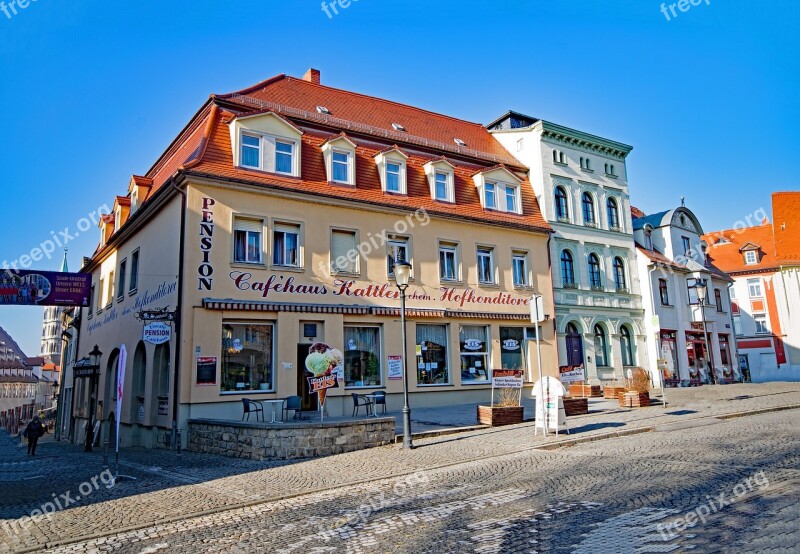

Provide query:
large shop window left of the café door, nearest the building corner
left=221, top=323, right=274, bottom=393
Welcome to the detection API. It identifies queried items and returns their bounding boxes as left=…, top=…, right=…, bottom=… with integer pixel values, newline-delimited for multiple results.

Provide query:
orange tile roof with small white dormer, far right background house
left=702, top=223, right=778, bottom=273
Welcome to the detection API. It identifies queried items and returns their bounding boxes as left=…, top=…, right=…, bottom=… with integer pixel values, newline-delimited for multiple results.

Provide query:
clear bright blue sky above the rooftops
left=0, top=0, right=800, bottom=355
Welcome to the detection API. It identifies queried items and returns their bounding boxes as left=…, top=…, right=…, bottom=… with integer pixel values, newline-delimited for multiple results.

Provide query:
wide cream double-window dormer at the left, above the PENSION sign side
left=228, top=112, right=303, bottom=177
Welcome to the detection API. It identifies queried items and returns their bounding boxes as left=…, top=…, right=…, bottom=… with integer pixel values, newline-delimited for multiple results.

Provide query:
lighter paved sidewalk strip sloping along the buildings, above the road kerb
left=0, top=383, right=800, bottom=551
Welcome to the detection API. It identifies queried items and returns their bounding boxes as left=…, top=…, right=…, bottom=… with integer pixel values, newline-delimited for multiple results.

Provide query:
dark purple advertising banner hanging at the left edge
left=0, top=270, right=92, bottom=307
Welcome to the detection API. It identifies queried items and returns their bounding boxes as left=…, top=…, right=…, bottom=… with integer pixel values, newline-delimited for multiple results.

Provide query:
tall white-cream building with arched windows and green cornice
left=488, top=112, right=647, bottom=383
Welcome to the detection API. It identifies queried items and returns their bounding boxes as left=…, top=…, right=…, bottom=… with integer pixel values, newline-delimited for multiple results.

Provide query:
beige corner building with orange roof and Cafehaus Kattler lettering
left=75, top=70, right=557, bottom=445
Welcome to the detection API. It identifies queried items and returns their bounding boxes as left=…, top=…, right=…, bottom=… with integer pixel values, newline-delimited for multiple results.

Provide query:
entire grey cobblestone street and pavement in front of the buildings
left=0, top=383, right=800, bottom=553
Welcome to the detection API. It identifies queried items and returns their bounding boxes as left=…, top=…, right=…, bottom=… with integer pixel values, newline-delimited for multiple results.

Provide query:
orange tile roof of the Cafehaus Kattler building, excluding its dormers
left=131, top=70, right=550, bottom=232
